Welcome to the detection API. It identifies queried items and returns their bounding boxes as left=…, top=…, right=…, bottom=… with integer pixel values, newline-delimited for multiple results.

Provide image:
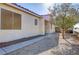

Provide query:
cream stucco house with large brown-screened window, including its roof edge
left=0, top=3, right=54, bottom=47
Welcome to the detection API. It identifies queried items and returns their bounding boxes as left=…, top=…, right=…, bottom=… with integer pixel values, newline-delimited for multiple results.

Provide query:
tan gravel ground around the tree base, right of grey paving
left=39, top=34, right=79, bottom=55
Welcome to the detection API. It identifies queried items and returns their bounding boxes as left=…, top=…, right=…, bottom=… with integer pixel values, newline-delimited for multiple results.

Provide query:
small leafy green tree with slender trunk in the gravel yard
left=49, top=3, right=78, bottom=39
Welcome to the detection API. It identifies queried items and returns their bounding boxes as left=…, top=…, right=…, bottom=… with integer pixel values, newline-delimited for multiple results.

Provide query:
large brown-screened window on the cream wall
left=1, top=9, right=21, bottom=29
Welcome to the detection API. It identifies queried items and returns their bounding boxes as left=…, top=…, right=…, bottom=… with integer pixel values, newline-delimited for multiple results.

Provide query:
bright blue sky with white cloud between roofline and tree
left=17, top=3, right=53, bottom=15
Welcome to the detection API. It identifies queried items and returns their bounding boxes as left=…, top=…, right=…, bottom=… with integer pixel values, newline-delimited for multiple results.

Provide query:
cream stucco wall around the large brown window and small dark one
left=0, top=4, right=44, bottom=42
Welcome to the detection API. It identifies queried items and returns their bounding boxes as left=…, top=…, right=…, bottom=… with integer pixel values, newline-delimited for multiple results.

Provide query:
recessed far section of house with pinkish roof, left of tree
left=42, top=14, right=55, bottom=34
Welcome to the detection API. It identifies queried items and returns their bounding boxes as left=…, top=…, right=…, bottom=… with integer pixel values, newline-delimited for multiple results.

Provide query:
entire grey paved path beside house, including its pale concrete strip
left=0, top=33, right=58, bottom=55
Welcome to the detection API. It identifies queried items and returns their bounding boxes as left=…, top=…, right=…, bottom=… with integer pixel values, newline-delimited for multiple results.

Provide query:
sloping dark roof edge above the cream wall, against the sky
left=5, top=3, right=41, bottom=17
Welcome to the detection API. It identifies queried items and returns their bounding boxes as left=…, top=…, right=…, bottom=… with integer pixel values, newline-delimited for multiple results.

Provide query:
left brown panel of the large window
left=1, top=9, right=12, bottom=29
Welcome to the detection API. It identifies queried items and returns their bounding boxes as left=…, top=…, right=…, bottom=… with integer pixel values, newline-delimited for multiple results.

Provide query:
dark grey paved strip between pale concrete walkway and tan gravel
left=7, top=33, right=58, bottom=55
